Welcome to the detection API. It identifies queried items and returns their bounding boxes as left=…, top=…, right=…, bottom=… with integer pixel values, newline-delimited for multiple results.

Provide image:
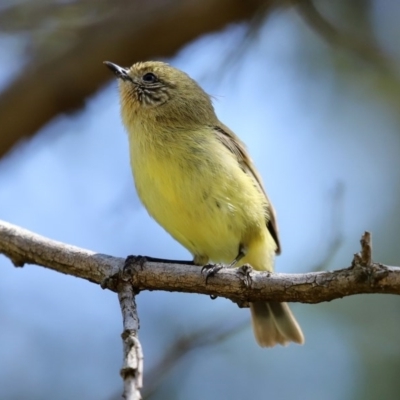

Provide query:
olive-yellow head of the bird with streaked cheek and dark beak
left=104, top=61, right=216, bottom=127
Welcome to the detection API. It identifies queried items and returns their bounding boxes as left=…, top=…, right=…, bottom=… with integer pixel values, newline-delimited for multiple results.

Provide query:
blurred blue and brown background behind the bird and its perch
left=0, top=0, right=400, bottom=400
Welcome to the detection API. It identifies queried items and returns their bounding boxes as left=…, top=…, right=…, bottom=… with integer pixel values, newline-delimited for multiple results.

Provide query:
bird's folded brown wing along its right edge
left=214, top=123, right=281, bottom=254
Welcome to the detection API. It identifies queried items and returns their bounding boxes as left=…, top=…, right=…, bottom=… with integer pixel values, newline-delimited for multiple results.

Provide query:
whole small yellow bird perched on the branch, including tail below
left=105, top=61, right=304, bottom=347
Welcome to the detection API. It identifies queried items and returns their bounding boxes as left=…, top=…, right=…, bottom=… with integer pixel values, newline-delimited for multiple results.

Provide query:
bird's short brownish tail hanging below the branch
left=250, top=301, right=304, bottom=347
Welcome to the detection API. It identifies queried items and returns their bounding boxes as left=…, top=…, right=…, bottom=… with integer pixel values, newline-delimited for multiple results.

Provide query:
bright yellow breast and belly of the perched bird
left=131, top=130, right=275, bottom=270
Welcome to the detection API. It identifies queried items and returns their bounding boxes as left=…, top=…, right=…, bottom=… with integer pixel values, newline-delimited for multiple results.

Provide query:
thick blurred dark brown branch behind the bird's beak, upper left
left=0, top=0, right=269, bottom=157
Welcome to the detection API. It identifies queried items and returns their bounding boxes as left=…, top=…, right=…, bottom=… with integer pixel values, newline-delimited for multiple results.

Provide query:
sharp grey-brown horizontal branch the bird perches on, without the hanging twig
left=0, top=221, right=400, bottom=303
